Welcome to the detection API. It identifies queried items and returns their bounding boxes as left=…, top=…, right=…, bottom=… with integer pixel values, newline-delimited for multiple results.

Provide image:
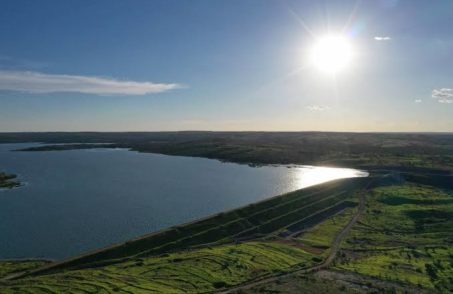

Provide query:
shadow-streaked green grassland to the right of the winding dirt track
left=337, top=183, right=453, bottom=292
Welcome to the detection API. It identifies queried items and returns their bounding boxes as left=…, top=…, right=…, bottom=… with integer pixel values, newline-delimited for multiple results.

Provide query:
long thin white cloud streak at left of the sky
left=0, top=70, right=182, bottom=95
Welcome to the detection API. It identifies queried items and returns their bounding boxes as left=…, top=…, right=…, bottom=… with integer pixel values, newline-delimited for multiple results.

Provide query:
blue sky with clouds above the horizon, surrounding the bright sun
left=0, top=0, right=453, bottom=132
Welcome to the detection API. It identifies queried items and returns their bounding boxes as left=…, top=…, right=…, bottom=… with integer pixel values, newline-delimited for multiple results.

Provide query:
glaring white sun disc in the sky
left=311, top=35, right=352, bottom=74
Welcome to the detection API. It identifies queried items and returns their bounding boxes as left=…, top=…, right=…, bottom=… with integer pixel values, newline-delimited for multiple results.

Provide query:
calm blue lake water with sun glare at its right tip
left=0, top=144, right=363, bottom=259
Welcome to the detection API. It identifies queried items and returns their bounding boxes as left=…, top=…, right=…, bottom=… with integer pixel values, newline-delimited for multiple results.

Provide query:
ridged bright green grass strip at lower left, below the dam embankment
left=0, top=242, right=315, bottom=294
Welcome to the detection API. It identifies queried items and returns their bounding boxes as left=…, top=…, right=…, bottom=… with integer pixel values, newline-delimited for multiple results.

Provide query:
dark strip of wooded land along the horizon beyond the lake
left=4, top=132, right=453, bottom=169
